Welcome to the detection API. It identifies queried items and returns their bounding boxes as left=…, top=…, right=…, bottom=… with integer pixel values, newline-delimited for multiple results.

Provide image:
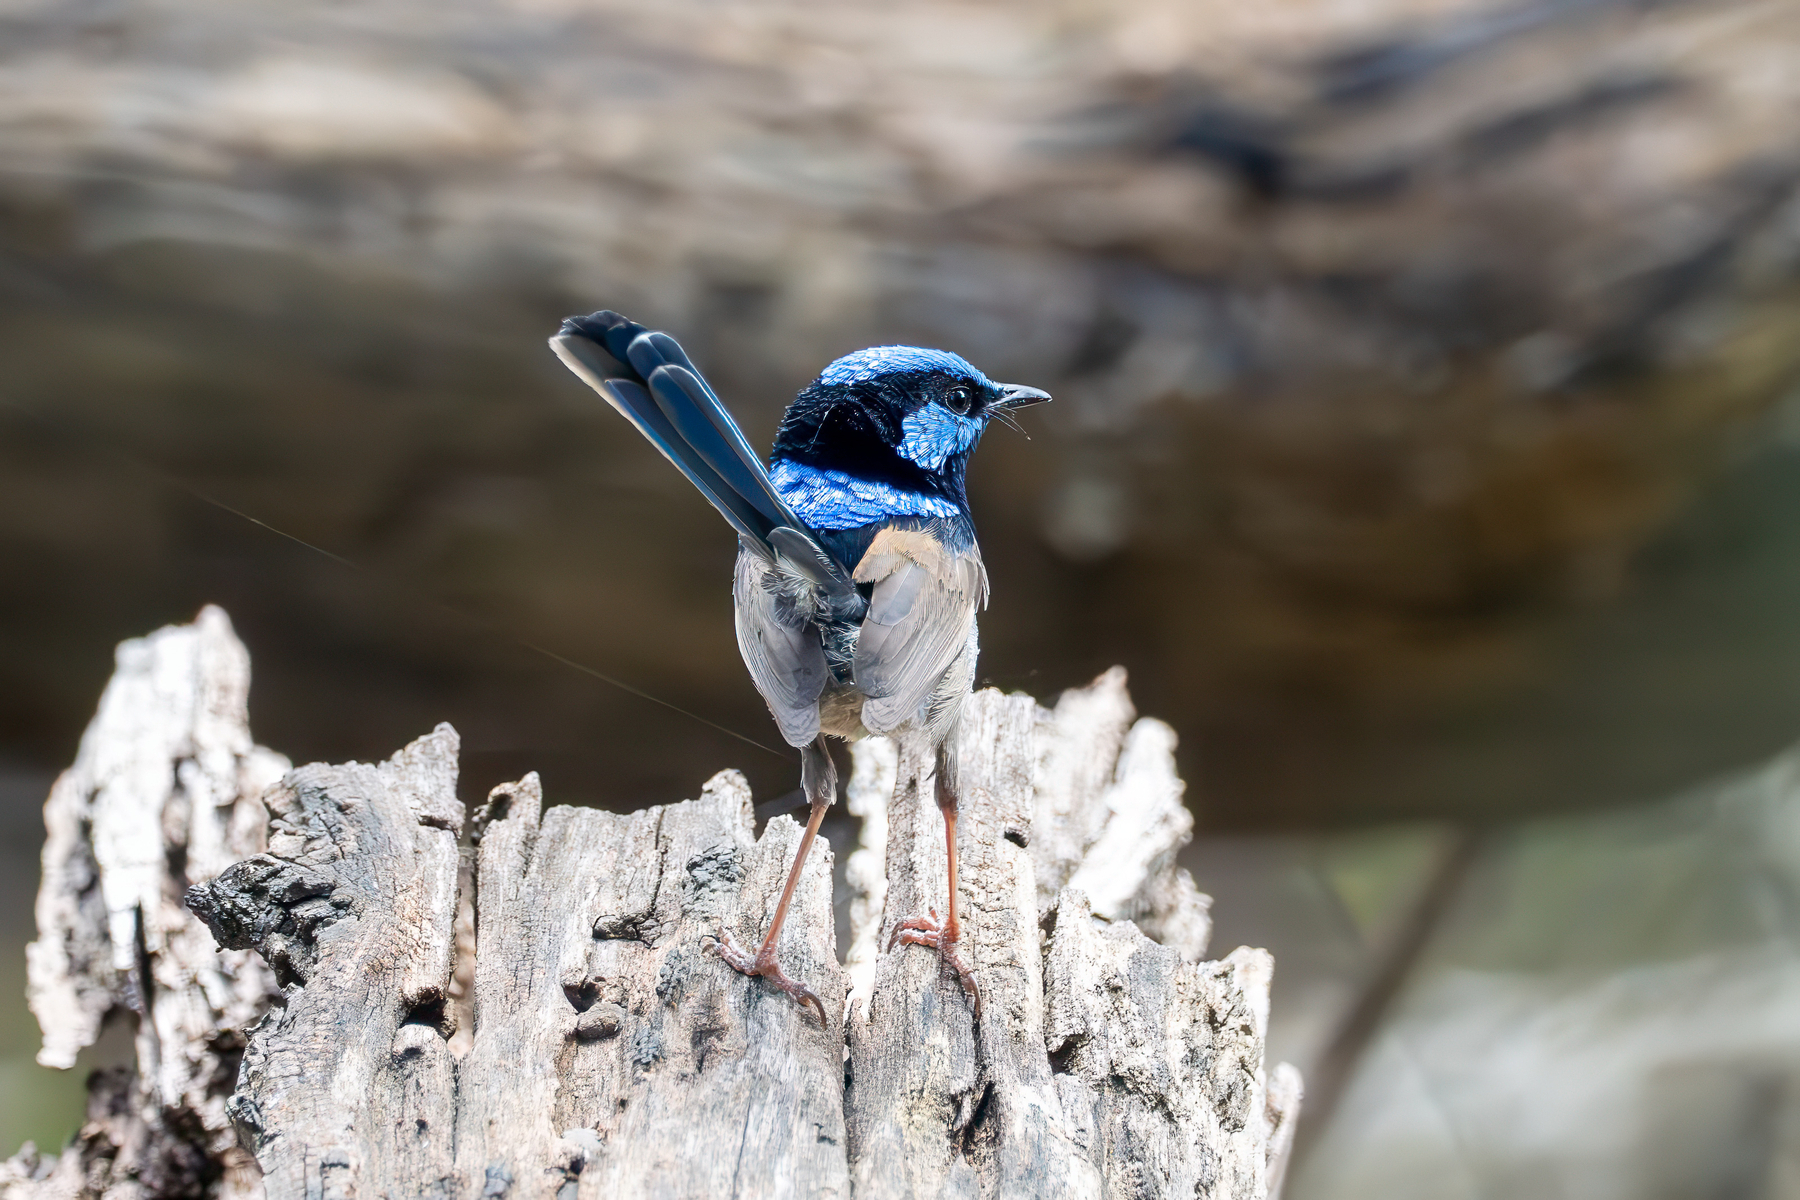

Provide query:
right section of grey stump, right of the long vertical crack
left=846, top=669, right=1300, bottom=1198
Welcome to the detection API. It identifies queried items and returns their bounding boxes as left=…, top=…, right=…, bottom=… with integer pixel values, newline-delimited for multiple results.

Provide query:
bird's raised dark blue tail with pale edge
left=551, top=309, right=855, bottom=596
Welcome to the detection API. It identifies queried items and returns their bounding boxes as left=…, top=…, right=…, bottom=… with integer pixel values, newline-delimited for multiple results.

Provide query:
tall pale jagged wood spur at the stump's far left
left=10, top=608, right=288, bottom=1196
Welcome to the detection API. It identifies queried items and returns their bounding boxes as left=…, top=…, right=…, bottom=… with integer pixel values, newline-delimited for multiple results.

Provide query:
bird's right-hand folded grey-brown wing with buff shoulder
left=853, top=531, right=986, bottom=734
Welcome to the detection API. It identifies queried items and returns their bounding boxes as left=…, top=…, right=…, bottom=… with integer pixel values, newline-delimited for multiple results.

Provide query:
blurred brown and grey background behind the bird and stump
left=0, top=0, right=1800, bottom=1200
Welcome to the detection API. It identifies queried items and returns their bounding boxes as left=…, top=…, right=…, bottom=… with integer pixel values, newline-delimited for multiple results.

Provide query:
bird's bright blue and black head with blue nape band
left=770, top=345, right=1049, bottom=529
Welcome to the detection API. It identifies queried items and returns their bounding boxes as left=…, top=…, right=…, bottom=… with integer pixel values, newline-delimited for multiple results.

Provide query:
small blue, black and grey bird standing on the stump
left=551, top=309, right=1049, bottom=1024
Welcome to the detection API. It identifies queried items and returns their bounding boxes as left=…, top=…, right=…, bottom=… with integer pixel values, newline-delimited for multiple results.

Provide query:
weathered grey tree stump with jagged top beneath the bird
left=0, top=610, right=1300, bottom=1200
